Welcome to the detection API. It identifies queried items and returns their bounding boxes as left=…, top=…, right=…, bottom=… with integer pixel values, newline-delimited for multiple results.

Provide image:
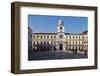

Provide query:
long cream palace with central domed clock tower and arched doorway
left=32, top=20, right=88, bottom=51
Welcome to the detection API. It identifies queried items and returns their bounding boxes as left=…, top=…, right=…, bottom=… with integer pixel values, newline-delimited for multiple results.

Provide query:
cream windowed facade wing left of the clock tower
left=32, top=34, right=56, bottom=51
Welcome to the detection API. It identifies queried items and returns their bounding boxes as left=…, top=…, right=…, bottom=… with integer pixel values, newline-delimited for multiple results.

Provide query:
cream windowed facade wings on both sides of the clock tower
left=32, top=33, right=88, bottom=51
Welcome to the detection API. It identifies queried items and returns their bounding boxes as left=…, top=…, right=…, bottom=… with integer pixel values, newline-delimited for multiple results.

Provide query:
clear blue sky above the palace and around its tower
left=28, top=15, right=88, bottom=33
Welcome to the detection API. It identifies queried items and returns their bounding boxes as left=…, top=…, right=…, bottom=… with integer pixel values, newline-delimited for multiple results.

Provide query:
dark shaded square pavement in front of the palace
left=28, top=51, right=87, bottom=60
